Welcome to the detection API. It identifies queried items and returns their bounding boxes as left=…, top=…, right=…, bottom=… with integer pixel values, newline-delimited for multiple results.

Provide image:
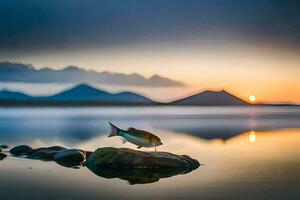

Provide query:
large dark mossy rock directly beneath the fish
left=86, top=147, right=200, bottom=184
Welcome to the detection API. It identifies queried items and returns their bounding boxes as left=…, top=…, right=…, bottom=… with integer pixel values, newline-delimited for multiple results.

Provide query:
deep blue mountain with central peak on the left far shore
left=0, top=84, right=155, bottom=105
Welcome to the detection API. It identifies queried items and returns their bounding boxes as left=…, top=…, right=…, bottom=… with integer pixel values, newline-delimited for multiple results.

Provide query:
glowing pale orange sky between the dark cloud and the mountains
left=5, top=41, right=300, bottom=103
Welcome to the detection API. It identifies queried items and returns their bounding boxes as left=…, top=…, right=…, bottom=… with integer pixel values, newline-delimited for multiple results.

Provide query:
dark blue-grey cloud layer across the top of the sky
left=0, top=0, right=300, bottom=52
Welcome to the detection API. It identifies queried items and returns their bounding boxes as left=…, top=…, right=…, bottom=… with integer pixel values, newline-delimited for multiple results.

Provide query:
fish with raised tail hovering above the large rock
left=108, top=122, right=163, bottom=151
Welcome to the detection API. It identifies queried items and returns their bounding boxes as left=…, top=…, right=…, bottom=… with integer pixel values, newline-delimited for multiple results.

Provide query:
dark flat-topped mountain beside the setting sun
left=170, top=90, right=249, bottom=106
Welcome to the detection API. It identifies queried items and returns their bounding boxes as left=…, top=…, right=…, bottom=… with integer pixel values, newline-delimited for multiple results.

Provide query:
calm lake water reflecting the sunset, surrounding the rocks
left=0, top=107, right=300, bottom=200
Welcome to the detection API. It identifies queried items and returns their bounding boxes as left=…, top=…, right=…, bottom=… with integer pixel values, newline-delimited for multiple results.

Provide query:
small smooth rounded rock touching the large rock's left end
left=54, top=149, right=86, bottom=163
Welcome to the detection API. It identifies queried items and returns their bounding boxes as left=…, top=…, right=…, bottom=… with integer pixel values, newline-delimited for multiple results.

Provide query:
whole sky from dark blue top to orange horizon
left=0, top=0, right=300, bottom=103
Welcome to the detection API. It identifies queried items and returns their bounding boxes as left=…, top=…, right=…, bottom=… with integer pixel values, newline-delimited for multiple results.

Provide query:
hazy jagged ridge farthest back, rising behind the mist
left=0, top=62, right=184, bottom=87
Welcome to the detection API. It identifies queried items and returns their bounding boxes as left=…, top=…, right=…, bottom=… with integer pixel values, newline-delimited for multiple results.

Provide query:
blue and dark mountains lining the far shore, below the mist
left=0, top=84, right=249, bottom=106
